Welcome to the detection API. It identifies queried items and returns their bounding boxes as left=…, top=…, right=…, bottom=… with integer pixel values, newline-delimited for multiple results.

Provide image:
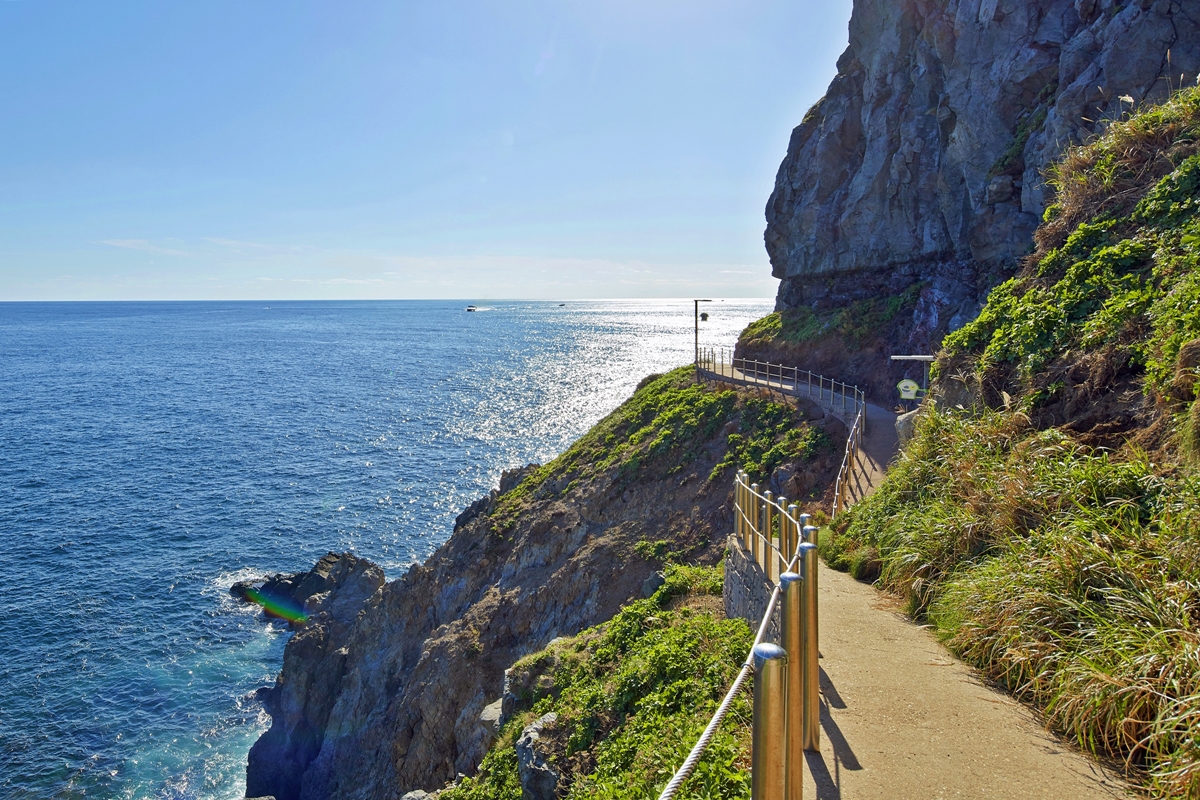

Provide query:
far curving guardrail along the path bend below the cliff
left=696, top=348, right=866, bottom=518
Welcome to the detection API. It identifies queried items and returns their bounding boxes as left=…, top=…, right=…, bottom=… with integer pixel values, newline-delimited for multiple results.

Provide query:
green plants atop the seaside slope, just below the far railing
left=492, top=367, right=833, bottom=533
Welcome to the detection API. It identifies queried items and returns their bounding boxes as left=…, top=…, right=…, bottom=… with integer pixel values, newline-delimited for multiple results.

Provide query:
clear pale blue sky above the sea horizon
left=0, top=0, right=850, bottom=300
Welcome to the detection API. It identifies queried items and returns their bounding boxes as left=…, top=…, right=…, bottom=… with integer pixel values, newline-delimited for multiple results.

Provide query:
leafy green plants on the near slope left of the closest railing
left=442, top=566, right=754, bottom=800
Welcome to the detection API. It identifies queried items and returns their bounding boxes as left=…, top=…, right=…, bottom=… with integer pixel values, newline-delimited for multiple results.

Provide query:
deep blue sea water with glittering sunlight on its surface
left=0, top=300, right=770, bottom=799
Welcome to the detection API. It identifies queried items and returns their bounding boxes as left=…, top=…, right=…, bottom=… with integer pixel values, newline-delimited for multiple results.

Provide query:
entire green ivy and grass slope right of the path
left=822, top=90, right=1200, bottom=798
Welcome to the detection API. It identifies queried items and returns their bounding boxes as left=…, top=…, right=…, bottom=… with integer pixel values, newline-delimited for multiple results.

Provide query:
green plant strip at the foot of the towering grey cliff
left=738, top=283, right=925, bottom=350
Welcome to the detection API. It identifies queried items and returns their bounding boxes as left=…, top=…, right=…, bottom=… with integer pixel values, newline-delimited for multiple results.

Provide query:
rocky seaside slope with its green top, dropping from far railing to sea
left=246, top=369, right=845, bottom=800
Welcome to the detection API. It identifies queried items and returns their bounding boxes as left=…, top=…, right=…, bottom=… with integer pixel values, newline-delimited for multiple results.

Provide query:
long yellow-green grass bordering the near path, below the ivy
left=821, top=411, right=1200, bottom=798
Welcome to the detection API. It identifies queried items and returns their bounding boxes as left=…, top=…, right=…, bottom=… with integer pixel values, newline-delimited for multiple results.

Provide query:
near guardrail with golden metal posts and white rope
left=659, top=471, right=821, bottom=800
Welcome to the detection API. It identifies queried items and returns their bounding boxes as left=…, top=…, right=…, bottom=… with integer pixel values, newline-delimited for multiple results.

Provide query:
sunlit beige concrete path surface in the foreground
left=804, top=569, right=1130, bottom=800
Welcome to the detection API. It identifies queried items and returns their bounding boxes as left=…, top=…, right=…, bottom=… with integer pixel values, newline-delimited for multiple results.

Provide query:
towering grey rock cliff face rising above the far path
left=766, top=0, right=1200, bottom=385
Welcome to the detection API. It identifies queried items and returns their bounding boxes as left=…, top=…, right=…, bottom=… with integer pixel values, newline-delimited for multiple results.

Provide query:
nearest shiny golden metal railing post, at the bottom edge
left=750, top=643, right=787, bottom=800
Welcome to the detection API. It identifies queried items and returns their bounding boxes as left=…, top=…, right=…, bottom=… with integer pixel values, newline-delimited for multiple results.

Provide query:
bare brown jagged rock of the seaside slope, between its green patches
left=246, top=373, right=845, bottom=800
